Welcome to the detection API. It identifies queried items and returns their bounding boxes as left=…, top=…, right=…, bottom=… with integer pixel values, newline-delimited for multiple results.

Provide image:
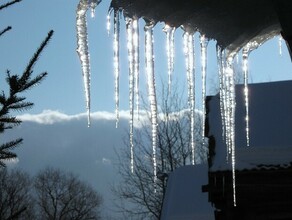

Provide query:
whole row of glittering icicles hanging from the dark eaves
left=77, top=0, right=281, bottom=206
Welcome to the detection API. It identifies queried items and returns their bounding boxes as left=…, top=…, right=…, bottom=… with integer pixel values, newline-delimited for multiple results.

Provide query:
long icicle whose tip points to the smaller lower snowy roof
left=183, top=32, right=195, bottom=164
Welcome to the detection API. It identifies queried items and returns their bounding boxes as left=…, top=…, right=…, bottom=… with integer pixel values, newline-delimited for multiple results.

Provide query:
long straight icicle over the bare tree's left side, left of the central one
left=126, top=18, right=135, bottom=173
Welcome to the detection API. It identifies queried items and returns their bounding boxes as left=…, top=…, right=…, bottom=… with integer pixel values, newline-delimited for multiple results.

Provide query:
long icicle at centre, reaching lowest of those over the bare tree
left=144, top=22, right=157, bottom=192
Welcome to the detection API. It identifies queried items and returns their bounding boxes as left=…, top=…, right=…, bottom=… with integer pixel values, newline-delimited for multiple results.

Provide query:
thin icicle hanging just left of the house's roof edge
left=200, top=35, right=208, bottom=141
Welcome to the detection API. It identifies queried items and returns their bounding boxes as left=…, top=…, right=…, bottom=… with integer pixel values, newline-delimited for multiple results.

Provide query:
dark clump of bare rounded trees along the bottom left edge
left=0, top=168, right=102, bottom=220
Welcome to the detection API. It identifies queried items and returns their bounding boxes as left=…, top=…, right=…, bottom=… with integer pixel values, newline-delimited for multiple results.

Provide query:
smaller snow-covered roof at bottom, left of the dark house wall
left=161, top=164, right=214, bottom=220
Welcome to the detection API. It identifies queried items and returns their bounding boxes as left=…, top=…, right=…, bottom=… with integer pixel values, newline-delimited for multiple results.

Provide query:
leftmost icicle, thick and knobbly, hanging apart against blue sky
left=76, top=0, right=100, bottom=126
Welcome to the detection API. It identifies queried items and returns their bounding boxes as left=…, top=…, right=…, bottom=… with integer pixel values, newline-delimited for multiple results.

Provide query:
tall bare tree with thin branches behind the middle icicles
left=113, top=85, right=207, bottom=219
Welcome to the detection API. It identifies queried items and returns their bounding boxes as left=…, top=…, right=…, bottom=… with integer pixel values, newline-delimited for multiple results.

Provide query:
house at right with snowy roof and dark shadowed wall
left=202, top=81, right=292, bottom=220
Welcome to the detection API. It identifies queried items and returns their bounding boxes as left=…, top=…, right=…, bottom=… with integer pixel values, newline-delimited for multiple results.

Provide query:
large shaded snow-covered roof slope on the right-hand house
left=209, top=81, right=292, bottom=171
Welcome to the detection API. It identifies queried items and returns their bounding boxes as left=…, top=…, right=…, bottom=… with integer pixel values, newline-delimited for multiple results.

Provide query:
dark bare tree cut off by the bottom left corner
left=0, top=169, right=34, bottom=220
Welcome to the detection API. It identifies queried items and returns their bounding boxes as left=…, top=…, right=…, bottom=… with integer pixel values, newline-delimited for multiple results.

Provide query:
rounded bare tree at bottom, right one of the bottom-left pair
left=34, top=168, right=102, bottom=220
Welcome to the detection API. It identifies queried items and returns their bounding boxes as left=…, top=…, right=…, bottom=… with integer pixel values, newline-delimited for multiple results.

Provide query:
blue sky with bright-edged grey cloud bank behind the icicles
left=0, top=0, right=292, bottom=219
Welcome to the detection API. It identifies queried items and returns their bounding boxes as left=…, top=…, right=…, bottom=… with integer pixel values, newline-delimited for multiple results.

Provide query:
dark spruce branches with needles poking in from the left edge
left=0, top=0, right=53, bottom=168
